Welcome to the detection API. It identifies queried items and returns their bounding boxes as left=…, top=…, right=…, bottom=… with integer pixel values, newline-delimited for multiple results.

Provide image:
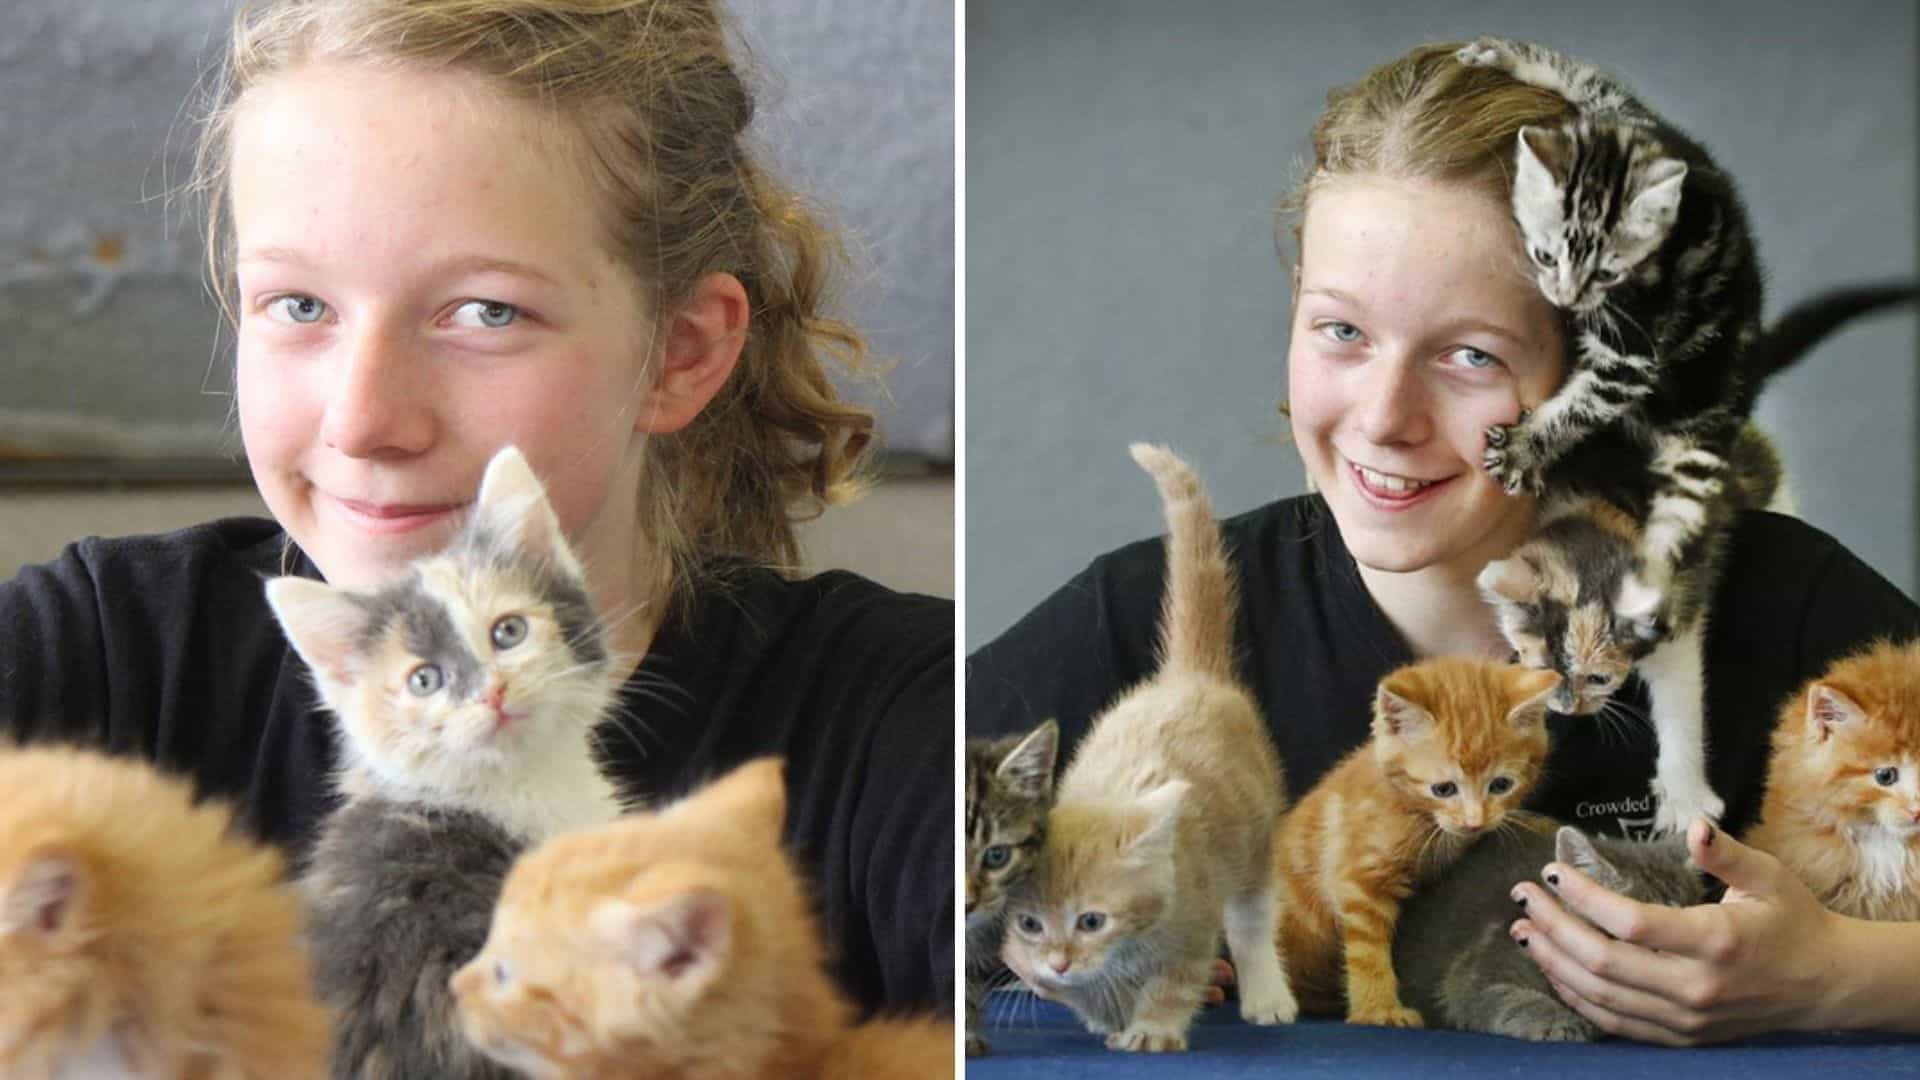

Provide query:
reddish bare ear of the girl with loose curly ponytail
left=634, top=273, right=751, bottom=434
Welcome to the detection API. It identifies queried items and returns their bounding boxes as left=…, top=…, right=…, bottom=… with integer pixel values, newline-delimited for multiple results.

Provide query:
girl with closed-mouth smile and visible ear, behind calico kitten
left=0, top=0, right=952, bottom=1007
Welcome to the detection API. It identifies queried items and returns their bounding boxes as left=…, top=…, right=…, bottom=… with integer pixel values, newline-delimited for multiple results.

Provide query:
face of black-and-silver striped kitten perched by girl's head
left=1513, top=119, right=1686, bottom=311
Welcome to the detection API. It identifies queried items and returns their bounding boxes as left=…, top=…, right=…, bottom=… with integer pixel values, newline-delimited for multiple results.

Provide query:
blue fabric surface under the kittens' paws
left=966, top=992, right=1920, bottom=1080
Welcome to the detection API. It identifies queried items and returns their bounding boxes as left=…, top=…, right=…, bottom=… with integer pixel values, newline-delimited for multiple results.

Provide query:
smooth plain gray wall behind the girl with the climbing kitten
left=966, top=0, right=1920, bottom=648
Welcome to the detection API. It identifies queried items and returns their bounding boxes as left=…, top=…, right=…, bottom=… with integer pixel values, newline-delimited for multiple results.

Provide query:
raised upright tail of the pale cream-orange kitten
left=1127, top=442, right=1235, bottom=680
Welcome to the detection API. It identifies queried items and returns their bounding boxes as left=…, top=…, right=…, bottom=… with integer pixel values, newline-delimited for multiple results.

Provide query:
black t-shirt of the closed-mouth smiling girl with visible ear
left=0, top=519, right=954, bottom=1009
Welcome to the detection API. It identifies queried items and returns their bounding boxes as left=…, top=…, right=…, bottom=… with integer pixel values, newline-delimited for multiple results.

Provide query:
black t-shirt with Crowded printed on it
left=966, top=496, right=1920, bottom=836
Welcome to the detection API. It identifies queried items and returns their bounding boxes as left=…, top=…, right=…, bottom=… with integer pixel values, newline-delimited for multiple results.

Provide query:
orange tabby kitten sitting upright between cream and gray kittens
left=1275, top=657, right=1559, bottom=1028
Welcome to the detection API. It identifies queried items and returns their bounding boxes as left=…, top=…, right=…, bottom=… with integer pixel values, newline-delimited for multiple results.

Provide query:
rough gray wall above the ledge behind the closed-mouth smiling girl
left=0, top=0, right=954, bottom=459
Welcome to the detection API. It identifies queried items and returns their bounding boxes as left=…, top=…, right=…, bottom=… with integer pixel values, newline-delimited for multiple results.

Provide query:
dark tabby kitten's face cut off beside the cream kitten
left=966, top=721, right=1060, bottom=926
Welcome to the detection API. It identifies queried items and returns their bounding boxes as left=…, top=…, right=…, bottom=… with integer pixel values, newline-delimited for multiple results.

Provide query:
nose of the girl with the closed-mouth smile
left=321, top=319, right=434, bottom=457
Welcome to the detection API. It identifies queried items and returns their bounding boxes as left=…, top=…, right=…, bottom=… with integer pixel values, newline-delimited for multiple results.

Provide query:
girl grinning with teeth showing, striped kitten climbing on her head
left=968, top=44, right=1920, bottom=1042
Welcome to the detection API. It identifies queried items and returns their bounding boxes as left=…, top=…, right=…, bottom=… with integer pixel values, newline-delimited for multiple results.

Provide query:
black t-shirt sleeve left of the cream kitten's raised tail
left=966, top=540, right=1165, bottom=746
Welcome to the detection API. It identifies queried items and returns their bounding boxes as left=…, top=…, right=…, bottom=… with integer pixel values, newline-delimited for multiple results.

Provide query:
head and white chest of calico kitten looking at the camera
left=267, top=446, right=624, bottom=838
